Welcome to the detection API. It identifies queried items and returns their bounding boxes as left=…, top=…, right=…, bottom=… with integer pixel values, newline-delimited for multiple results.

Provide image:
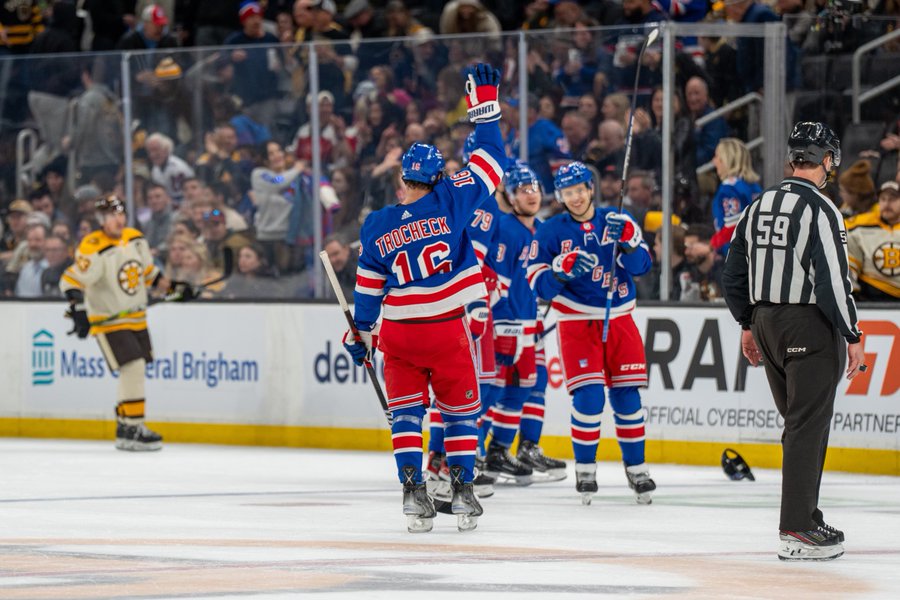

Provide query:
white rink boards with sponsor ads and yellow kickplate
left=0, top=302, right=900, bottom=474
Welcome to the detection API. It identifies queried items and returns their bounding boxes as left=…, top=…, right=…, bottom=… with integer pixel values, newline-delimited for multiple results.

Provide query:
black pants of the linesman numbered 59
left=751, top=304, right=846, bottom=531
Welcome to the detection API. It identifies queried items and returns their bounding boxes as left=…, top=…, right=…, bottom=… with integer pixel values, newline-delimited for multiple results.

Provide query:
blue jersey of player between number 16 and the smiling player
left=493, top=214, right=539, bottom=328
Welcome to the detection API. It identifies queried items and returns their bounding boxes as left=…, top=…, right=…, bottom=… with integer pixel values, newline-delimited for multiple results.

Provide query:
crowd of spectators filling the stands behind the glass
left=0, top=0, right=900, bottom=301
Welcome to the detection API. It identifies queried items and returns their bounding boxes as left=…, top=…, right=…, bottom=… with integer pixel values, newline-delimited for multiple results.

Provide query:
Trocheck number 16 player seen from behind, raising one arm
left=344, top=64, right=506, bottom=532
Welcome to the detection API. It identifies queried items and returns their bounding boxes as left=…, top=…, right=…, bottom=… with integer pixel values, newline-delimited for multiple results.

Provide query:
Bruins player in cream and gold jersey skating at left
left=59, top=195, right=162, bottom=451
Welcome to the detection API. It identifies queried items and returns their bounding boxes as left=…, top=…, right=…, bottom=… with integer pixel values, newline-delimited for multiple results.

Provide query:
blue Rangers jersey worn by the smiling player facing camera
left=528, top=208, right=652, bottom=321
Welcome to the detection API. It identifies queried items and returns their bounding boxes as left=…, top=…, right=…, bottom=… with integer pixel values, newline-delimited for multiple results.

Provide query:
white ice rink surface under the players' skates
left=0, top=439, right=900, bottom=600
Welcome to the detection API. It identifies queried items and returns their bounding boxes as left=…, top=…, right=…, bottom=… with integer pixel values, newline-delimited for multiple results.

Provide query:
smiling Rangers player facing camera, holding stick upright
left=528, top=162, right=656, bottom=504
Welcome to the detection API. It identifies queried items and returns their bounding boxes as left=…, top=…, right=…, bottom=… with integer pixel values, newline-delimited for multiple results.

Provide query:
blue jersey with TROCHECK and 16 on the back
left=353, top=122, right=506, bottom=331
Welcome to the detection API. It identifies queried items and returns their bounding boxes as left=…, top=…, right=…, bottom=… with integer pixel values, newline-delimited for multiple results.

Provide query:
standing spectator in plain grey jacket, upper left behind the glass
left=62, top=68, right=122, bottom=185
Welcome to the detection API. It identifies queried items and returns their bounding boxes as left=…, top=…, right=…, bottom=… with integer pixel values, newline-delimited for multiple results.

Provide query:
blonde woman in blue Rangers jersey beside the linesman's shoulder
left=711, top=138, right=762, bottom=256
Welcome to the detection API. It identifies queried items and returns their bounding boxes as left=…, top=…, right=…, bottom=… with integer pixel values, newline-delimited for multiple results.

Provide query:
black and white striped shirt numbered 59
left=722, top=177, right=861, bottom=343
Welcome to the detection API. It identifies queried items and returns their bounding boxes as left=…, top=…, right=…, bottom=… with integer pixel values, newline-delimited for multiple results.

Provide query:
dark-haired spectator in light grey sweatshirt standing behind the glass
left=250, top=142, right=302, bottom=273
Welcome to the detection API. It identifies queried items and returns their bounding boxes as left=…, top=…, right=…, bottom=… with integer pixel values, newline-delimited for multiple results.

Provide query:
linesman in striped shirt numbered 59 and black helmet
left=723, top=122, right=866, bottom=560
